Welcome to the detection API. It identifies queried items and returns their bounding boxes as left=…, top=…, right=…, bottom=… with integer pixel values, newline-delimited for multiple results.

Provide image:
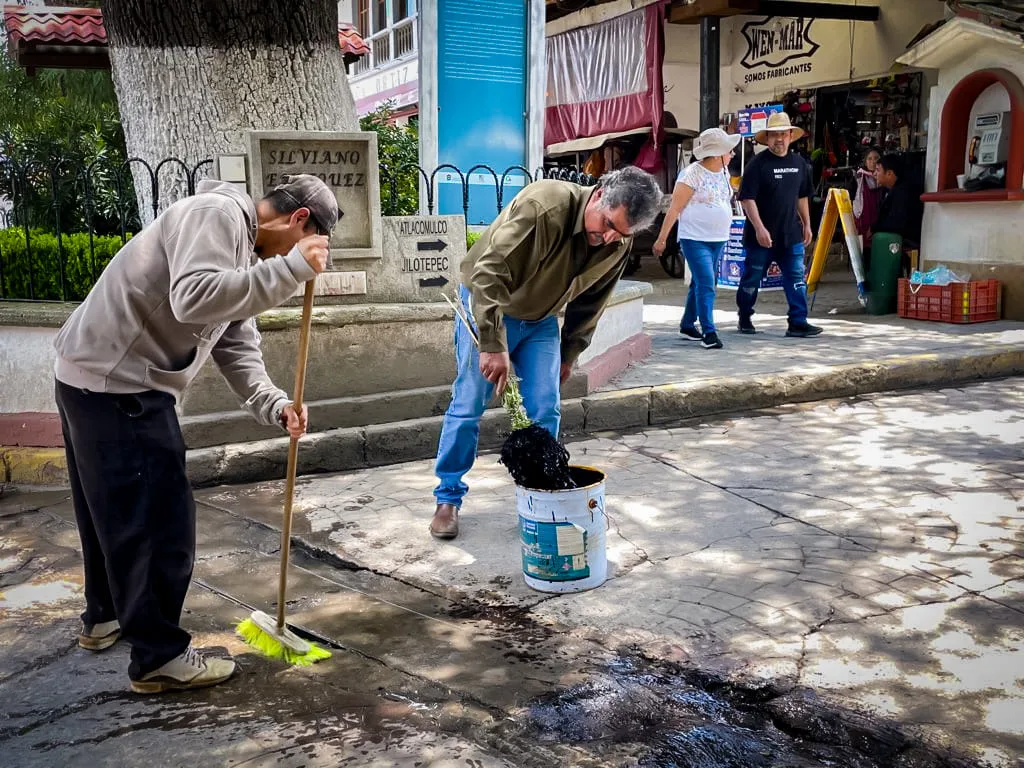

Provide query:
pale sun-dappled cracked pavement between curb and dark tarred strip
left=193, top=380, right=1024, bottom=766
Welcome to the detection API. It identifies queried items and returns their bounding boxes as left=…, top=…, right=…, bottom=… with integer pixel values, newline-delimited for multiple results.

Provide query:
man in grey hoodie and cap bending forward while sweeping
left=54, top=175, right=339, bottom=693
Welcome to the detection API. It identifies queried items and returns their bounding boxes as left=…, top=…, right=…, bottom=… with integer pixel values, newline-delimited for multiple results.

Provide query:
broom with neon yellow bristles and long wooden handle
left=237, top=280, right=331, bottom=667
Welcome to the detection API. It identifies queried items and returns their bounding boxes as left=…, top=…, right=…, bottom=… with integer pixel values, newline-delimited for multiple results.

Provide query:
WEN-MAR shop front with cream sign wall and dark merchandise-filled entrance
left=722, top=0, right=943, bottom=207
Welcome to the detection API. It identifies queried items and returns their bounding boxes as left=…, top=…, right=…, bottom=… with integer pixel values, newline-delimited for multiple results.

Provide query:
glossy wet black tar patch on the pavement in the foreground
left=527, top=653, right=977, bottom=768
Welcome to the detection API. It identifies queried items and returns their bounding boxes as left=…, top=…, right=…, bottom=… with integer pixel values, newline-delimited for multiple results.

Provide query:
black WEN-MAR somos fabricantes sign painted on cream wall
left=740, top=16, right=820, bottom=83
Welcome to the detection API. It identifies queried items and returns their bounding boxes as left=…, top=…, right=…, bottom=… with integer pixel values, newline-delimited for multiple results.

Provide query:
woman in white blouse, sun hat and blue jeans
left=651, top=128, right=740, bottom=349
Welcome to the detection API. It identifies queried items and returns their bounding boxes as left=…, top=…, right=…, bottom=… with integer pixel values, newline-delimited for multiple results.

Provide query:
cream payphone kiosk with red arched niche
left=901, top=17, right=1024, bottom=319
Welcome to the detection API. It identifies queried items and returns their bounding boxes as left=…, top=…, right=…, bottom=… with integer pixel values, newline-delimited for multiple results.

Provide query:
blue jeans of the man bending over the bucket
left=434, top=286, right=562, bottom=507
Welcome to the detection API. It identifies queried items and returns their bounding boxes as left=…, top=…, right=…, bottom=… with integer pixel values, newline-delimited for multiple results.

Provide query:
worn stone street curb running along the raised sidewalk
left=0, top=345, right=1024, bottom=487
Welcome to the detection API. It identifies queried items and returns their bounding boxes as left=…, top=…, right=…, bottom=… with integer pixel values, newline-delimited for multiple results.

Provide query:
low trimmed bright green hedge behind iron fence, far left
left=0, top=228, right=131, bottom=301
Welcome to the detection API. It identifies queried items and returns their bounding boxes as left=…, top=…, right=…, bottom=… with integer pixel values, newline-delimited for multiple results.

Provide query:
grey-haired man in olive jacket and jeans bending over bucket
left=430, top=167, right=663, bottom=539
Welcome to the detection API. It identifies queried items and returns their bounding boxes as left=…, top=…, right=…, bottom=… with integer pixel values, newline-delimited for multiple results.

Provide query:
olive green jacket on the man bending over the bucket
left=462, top=179, right=632, bottom=364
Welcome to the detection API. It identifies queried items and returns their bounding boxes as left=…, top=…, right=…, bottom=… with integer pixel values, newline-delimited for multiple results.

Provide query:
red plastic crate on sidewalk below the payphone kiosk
left=896, top=278, right=1002, bottom=323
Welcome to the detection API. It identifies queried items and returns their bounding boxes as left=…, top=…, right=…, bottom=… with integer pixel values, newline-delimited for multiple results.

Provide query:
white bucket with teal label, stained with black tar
left=515, top=467, right=608, bottom=592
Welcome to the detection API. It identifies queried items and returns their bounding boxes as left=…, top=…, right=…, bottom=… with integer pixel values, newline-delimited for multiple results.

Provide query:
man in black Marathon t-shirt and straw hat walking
left=736, top=113, right=821, bottom=338
